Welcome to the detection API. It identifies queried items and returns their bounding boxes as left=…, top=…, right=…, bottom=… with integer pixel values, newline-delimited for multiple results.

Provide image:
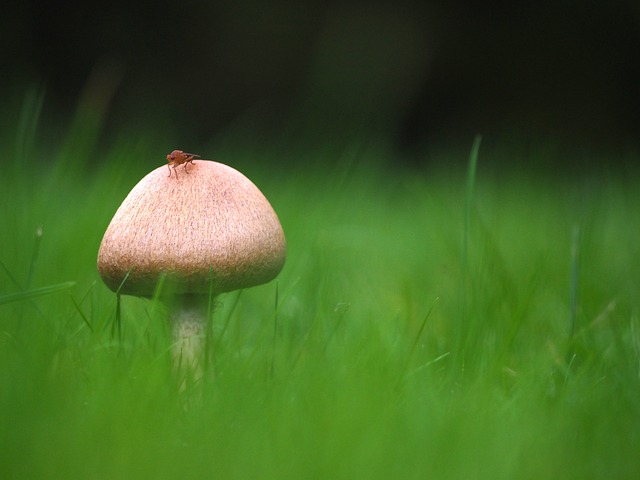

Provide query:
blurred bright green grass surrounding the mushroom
left=0, top=96, right=640, bottom=479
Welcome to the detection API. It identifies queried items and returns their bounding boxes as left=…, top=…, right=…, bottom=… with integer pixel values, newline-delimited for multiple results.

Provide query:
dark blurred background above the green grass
left=0, top=0, right=640, bottom=165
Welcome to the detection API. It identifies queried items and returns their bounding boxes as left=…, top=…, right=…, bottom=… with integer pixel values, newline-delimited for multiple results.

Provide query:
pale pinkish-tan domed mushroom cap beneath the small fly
left=98, top=160, right=286, bottom=296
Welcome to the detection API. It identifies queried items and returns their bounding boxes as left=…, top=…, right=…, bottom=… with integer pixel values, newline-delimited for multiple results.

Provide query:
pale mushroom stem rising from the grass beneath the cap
left=169, top=295, right=214, bottom=392
